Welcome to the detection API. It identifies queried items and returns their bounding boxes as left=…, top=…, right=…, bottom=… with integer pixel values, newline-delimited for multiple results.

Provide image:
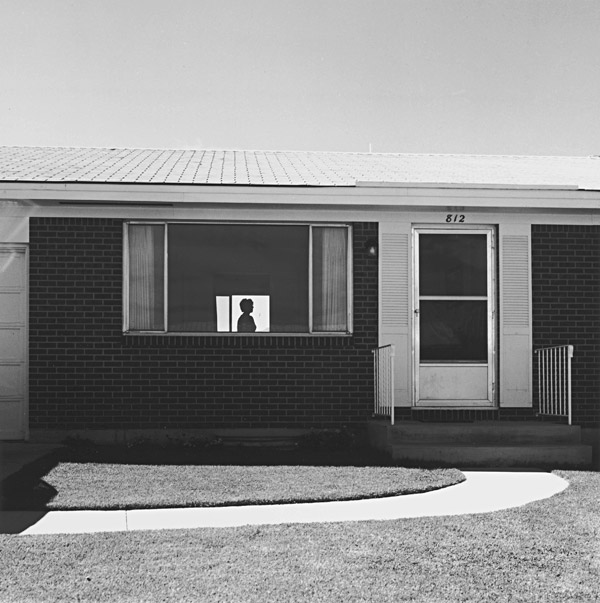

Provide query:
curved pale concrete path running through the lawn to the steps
left=3, top=471, right=569, bottom=534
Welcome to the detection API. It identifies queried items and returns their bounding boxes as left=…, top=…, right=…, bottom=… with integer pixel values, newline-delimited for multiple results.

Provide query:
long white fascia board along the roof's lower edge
left=0, top=182, right=600, bottom=210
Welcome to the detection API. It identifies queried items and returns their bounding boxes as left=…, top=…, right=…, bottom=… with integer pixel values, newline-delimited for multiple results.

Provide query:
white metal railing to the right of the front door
left=535, top=345, right=573, bottom=425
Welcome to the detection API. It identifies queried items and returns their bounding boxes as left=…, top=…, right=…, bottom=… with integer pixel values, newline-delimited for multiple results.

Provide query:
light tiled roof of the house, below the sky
left=0, top=147, right=600, bottom=191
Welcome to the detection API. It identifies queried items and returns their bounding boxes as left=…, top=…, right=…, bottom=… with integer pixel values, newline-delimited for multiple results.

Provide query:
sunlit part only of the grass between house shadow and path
left=36, top=462, right=465, bottom=510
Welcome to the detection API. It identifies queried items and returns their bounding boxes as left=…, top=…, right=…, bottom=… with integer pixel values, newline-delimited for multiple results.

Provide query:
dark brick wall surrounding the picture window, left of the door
left=30, top=218, right=377, bottom=429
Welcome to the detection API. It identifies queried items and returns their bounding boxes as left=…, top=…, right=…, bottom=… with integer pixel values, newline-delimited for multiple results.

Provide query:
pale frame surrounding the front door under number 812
left=411, top=224, right=498, bottom=408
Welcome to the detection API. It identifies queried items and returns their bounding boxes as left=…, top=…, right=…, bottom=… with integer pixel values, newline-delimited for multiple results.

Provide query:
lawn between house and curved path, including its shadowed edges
left=4, top=434, right=464, bottom=510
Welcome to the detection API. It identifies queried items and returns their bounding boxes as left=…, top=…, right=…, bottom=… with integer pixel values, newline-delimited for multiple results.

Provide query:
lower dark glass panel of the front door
left=419, top=300, right=488, bottom=363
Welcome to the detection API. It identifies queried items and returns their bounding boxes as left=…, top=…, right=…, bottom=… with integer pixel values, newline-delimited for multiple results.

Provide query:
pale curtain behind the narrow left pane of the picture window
left=129, top=224, right=165, bottom=331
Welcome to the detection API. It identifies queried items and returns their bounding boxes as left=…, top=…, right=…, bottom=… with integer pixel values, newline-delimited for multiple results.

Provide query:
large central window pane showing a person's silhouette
left=168, top=224, right=309, bottom=333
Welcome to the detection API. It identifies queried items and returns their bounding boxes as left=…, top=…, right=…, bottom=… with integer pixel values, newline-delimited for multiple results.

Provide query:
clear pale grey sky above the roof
left=0, top=0, right=600, bottom=155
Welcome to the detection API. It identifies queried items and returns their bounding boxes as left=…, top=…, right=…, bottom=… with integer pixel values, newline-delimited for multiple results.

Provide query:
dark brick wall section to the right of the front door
left=531, top=225, right=600, bottom=426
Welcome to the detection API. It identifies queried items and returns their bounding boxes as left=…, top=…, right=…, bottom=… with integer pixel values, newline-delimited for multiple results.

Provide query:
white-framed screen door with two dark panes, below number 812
left=414, top=227, right=495, bottom=407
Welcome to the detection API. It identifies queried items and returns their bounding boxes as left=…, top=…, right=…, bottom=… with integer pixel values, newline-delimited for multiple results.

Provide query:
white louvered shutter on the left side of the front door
left=379, top=222, right=412, bottom=406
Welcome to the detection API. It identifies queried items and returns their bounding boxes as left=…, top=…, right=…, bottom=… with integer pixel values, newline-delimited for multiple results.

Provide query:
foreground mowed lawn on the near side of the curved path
left=0, top=471, right=600, bottom=603
